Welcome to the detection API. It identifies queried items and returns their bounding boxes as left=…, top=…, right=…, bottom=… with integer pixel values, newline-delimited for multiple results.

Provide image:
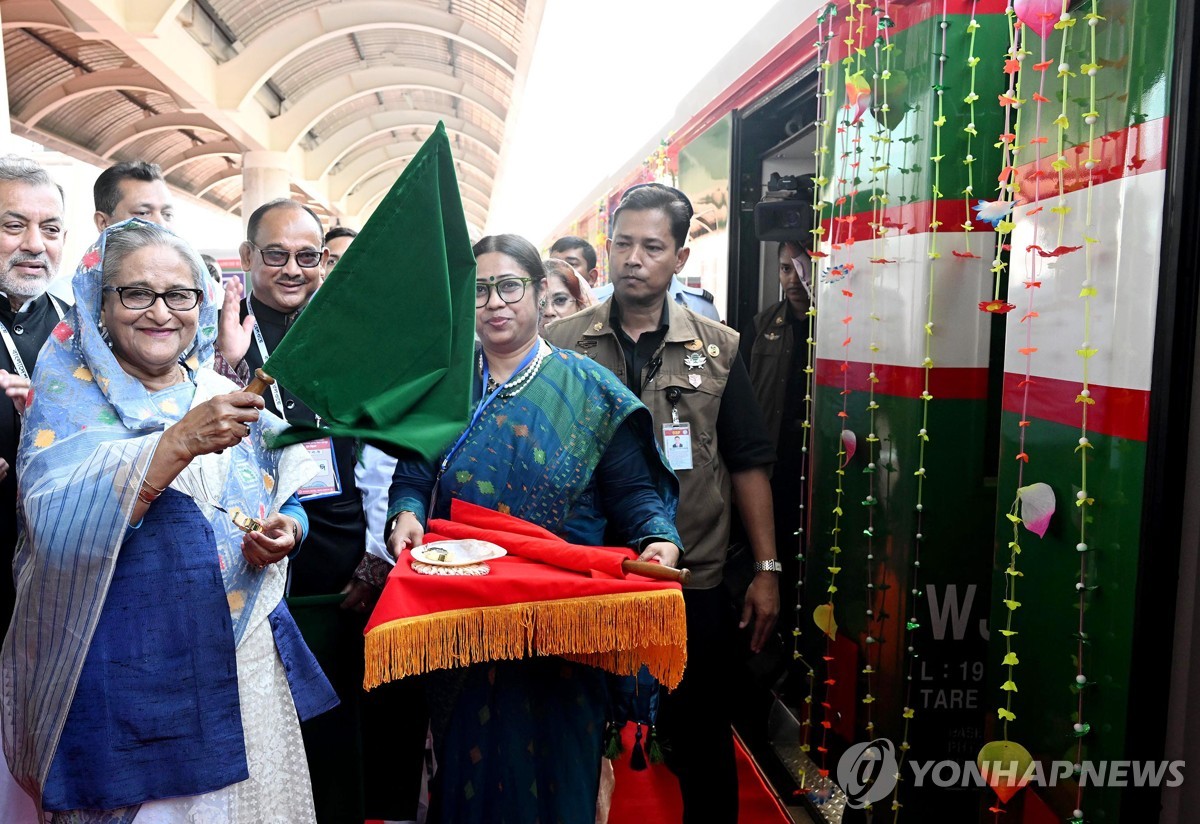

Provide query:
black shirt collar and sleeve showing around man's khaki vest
left=608, top=299, right=775, bottom=473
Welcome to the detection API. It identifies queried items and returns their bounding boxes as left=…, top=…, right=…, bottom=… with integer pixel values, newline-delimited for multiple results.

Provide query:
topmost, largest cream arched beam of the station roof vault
left=216, top=0, right=517, bottom=109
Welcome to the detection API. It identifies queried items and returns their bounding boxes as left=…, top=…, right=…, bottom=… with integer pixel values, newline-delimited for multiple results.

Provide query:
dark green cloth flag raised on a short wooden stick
left=263, top=124, right=475, bottom=461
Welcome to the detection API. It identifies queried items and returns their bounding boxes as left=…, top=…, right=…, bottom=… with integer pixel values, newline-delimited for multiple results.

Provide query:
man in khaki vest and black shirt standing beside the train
left=546, top=184, right=780, bottom=824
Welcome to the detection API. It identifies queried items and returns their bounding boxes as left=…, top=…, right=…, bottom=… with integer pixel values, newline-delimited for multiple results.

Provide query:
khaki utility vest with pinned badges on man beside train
left=546, top=301, right=738, bottom=589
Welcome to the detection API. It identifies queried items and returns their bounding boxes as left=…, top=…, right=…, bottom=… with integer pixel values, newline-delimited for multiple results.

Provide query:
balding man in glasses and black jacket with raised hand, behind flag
left=217, top=199, right=401, bottom=822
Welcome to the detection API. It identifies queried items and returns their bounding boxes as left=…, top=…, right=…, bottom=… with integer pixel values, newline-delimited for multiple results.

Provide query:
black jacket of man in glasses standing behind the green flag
left=241, top=296, right=367, bottom=596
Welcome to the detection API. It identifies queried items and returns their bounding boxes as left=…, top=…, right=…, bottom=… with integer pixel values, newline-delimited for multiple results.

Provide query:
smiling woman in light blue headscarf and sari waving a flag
left=0, top=219, right=336, bottom=824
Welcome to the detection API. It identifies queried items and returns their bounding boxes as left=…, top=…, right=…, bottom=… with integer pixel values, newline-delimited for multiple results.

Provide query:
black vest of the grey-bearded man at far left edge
left=0, top=294, right=64, bottom=627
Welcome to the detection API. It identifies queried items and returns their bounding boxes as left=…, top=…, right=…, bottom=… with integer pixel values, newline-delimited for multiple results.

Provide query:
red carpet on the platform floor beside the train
left=608, top=724, right=792, bottom=824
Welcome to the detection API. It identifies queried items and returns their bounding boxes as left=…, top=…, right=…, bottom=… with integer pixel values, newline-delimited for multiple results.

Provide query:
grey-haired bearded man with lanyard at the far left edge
left=0, top=155, right=67, bottom=824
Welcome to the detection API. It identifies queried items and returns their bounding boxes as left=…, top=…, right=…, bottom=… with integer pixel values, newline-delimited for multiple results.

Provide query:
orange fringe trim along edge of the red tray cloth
left=362, top=590, right=688, bottom=690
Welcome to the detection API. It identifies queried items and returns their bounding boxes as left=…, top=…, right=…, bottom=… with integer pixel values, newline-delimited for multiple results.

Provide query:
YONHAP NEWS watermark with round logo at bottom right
left=838, top=738, right=1186, bottom=808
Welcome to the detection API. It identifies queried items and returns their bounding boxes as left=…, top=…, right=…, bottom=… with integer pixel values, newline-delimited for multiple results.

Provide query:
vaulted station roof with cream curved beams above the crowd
left=0, top=0, right=545, bottom=230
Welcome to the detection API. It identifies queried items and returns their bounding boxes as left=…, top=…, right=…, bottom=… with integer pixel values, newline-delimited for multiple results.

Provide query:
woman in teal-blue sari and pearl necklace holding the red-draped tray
left=388, top=235, right=680, bottom=824
